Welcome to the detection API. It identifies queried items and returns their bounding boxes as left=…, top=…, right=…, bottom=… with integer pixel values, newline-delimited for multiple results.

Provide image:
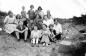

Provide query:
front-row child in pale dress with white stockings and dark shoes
left=31, top=26, right=41, bottom=45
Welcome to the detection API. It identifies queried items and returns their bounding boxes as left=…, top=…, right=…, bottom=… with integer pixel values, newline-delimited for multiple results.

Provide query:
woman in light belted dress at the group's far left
left=4, top=11, right=17, bottom=34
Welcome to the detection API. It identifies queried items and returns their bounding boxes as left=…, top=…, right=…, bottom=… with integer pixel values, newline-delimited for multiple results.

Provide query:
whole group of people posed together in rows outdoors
left=4, top=5, right=62, bottom=46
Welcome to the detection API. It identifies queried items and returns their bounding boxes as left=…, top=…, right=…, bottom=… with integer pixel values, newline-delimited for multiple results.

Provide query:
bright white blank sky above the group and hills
left=0, top=0, right=86, bottom=18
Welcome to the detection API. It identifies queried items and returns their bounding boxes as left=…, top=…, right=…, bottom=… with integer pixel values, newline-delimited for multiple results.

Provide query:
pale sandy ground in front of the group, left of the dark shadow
left=0, top=35, right=59, bottom=56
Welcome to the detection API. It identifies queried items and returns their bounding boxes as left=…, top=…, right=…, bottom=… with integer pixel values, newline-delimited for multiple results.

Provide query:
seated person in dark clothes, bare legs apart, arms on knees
left=15, top=21, right=28, bottom=42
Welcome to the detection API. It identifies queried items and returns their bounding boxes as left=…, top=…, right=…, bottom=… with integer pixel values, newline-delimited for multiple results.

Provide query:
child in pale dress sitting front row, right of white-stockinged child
left=41, top=24, right=50, bottom=46
